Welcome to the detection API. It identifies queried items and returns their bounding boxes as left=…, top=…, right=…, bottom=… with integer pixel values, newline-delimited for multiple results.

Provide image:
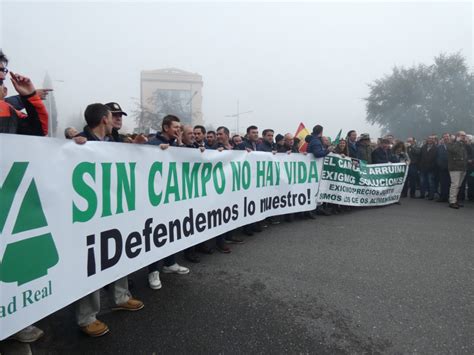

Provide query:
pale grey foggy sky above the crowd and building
left=0, top=0, right=473, bottom=137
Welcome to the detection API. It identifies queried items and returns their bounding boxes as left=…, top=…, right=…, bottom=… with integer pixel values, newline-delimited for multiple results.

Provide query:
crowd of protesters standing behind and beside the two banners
left=0, top=51, right=474, bottom=342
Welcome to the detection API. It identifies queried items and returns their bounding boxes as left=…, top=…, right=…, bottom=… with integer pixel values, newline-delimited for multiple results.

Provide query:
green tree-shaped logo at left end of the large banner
left=0, top=162, right=59, bottom=285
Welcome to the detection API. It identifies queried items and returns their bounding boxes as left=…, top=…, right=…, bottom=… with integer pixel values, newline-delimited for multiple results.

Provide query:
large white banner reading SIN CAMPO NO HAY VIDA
left=0, top=134, right=322, bottom=339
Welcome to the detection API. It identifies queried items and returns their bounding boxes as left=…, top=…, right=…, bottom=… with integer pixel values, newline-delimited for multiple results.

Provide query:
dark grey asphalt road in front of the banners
left=0, top=199, right=474, bottom=355
